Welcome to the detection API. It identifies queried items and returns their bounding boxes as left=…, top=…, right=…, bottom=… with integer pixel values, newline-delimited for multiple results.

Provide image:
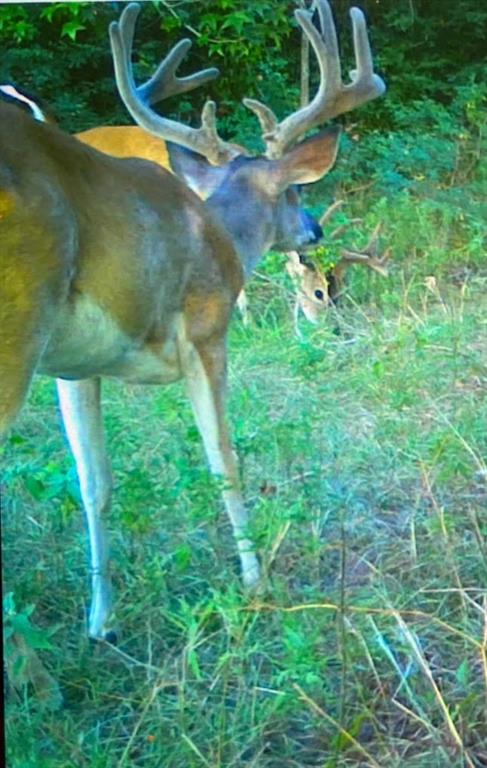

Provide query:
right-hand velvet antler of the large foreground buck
left=244, top=0, right=385, bottom=158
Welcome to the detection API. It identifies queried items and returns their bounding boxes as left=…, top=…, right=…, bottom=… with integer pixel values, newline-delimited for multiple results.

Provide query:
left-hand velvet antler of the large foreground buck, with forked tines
left=109, top=3, right=240, bottom=165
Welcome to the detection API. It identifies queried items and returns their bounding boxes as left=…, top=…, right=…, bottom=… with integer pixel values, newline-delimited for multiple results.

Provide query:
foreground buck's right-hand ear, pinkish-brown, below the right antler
left=264, top=126, right=341, bottom=192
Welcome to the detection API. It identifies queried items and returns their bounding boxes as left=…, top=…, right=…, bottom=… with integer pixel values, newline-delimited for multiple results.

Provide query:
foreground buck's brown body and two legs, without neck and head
left=0, top=67, right=259, bottom=638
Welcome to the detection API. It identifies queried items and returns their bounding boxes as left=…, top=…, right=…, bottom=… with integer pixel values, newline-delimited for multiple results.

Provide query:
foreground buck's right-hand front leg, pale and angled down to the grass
left=183, top=342, right=260, bottom=587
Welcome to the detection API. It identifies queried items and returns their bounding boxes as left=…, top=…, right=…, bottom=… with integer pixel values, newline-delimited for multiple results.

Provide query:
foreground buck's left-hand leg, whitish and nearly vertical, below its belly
left=57, top=379, right=114, bottom=641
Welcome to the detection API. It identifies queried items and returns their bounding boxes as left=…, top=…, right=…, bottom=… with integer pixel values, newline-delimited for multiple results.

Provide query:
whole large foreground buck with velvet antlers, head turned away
left=0, top=0, right=384, bottom=638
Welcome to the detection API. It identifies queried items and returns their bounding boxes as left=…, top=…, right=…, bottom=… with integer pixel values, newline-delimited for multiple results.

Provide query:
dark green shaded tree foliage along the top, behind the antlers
left=0, top=0, right=487, bottom=130
